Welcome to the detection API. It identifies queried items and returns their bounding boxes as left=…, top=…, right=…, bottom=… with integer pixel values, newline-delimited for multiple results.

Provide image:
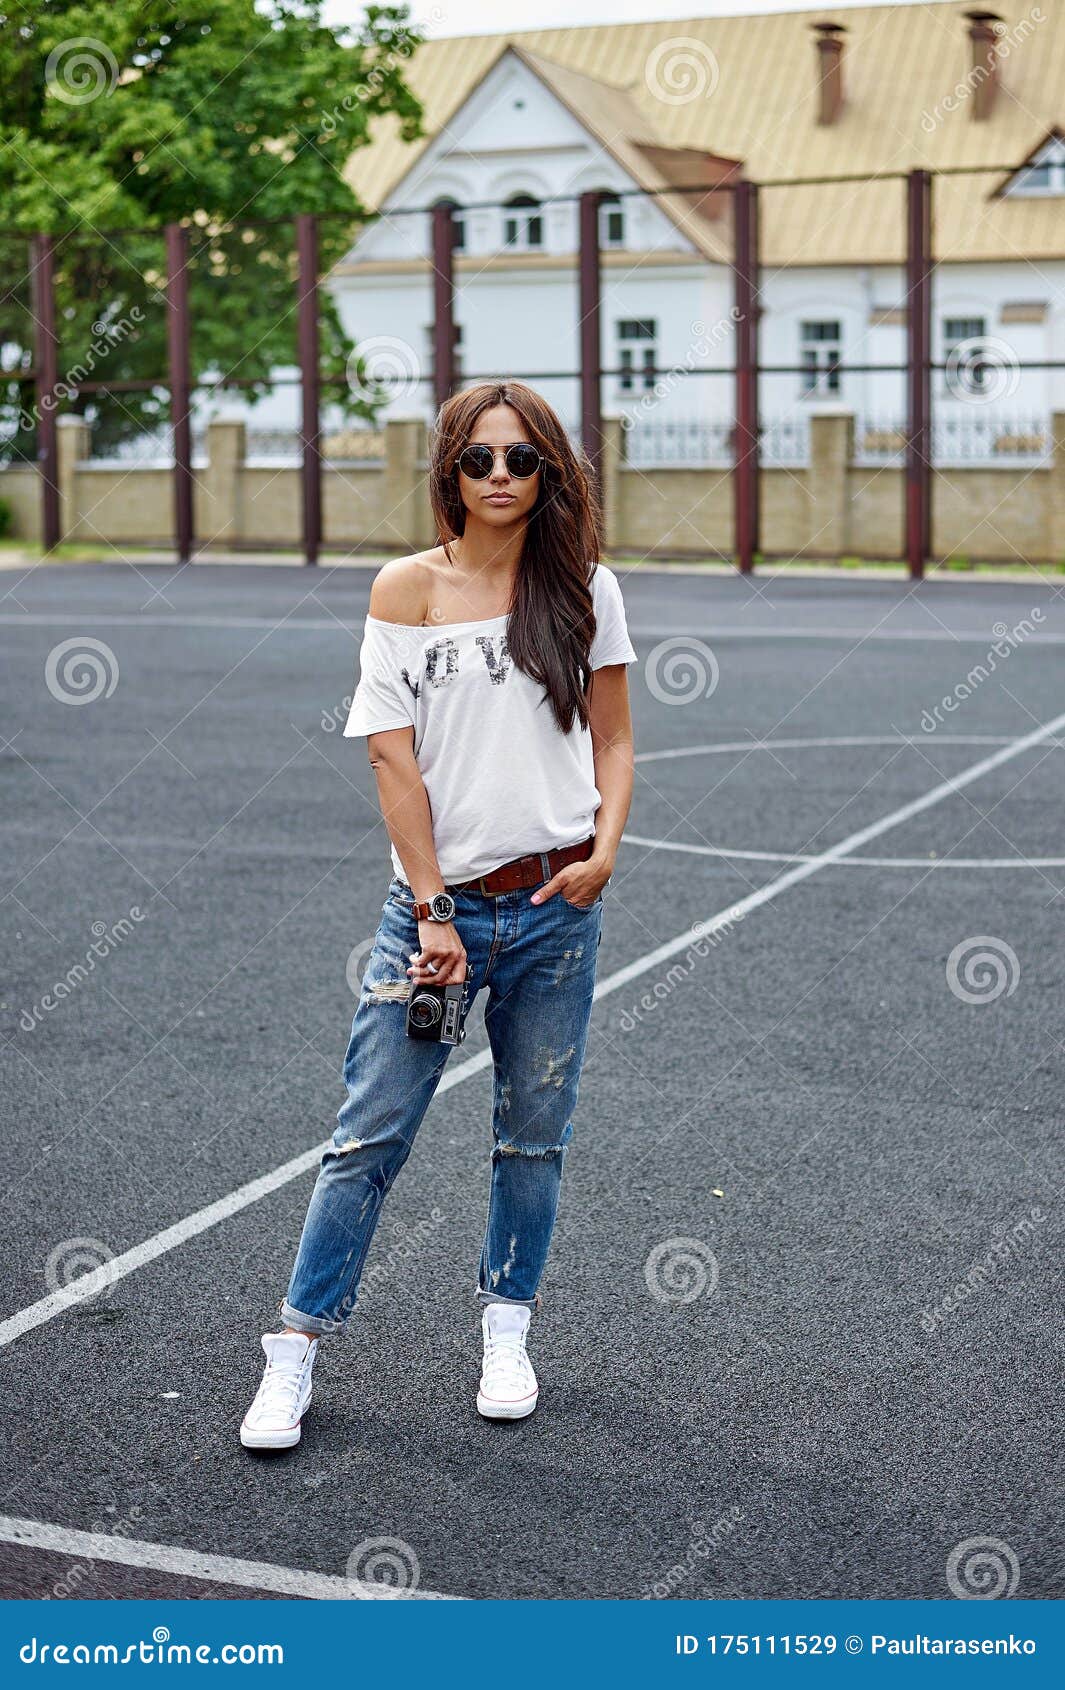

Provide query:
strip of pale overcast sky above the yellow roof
left=325, top=0, right=933, bottom=35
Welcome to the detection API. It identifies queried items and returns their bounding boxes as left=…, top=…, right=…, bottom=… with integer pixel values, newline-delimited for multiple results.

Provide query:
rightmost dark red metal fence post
left=906, top=171, right=931, bottom=581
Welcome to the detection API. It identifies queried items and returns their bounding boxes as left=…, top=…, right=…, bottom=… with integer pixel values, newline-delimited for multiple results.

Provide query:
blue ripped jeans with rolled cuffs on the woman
left=281, top=859, right=604, bottom=1333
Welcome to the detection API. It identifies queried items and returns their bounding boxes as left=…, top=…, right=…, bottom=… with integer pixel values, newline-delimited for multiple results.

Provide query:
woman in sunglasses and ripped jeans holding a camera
left=240, top=382, right=636, bottom=1450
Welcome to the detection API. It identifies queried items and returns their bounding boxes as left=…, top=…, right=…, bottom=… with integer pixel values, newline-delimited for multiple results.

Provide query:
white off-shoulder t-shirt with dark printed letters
left=343, top=563, right=637, bottom=884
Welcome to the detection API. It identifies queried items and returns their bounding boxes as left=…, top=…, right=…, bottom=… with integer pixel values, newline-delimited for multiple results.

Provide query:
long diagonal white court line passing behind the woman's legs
left=0, top=711, right=1065, bottom=1349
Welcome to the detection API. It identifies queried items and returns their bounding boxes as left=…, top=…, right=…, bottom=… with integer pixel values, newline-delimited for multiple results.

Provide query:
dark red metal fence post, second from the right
left=732, top=181, right=761, bottom=575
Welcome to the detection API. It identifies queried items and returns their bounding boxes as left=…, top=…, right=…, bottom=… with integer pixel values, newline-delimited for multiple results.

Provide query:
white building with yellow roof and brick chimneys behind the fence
left=208, top=0, right=1065, bottom=465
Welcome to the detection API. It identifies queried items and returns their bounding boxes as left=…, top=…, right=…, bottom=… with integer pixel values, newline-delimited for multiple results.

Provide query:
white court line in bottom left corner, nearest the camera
left=0, top=1514, right=465, bottom=1602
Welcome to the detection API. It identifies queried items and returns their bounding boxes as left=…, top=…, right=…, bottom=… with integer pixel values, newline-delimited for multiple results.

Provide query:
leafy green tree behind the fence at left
left=0, top=0, right=421, bottom=455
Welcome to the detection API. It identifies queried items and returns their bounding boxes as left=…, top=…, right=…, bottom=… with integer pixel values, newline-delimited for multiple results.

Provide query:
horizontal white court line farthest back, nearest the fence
left=0, top=610, right=1065, bottom=647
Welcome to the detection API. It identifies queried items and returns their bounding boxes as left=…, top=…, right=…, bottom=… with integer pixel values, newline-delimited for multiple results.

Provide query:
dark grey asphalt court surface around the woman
left=0, top=563, right=1065, bottom=1599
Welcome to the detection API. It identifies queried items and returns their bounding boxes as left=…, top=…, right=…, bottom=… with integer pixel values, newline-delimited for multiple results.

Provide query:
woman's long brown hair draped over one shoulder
left=429, top=382, right=600, bottom=733
